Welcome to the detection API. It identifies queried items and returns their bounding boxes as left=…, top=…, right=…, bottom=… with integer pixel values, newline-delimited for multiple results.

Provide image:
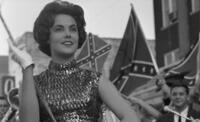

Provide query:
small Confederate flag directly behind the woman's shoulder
left=77, top=33, right=111, bottom=72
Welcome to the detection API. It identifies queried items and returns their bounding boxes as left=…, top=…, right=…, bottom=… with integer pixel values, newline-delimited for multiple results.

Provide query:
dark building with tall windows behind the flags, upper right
left=153, top=0, right=200, bottom=67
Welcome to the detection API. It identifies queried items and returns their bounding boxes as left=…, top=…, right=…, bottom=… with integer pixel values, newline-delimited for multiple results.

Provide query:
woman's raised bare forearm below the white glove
left=19, top=65, right=39, bottom=122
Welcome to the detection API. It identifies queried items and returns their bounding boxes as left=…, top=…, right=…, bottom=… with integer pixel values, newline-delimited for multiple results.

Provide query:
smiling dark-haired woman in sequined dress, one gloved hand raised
left=9, top=1, right=139, bottom=122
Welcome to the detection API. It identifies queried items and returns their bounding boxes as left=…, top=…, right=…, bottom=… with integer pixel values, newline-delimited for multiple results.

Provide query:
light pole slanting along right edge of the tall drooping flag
left=131, top=3, right=159, bottom=73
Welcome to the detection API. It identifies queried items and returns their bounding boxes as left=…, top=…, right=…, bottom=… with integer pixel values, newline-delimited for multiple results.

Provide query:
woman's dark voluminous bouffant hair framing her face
left=33, top=0, right=86, bottom=56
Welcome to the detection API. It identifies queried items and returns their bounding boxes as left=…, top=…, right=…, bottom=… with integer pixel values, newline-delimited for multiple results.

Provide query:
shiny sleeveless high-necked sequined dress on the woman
left=34, top=60, right=102, bottom=122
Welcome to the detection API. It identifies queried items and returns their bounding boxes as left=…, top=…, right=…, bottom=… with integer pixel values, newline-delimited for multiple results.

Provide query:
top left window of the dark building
left=162, top=0, right=177, bottom=27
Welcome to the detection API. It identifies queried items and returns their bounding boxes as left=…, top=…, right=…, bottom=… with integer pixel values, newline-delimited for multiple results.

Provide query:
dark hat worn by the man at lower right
left=165, top=72, right=189, bottom=88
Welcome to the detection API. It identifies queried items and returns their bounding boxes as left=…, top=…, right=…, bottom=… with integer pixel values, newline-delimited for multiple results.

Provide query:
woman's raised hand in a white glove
left=8, top=40, right=33, bottom=69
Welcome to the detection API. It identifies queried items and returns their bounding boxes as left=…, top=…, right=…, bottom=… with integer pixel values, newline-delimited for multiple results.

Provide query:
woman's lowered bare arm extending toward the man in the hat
left=99, top=76, right=139, bottom=122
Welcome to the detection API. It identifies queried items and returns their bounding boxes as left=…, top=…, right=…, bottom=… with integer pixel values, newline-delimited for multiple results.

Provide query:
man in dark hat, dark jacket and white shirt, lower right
left=156, top=73, right=200, bottom=122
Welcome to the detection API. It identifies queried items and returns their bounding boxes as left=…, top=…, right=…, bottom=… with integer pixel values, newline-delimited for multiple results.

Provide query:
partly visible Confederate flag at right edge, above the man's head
left=168, top=41, right=199, bottom=86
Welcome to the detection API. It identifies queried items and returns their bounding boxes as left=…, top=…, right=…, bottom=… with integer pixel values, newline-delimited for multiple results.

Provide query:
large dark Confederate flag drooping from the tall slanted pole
left=110, top=6, right=158, bottom=96
